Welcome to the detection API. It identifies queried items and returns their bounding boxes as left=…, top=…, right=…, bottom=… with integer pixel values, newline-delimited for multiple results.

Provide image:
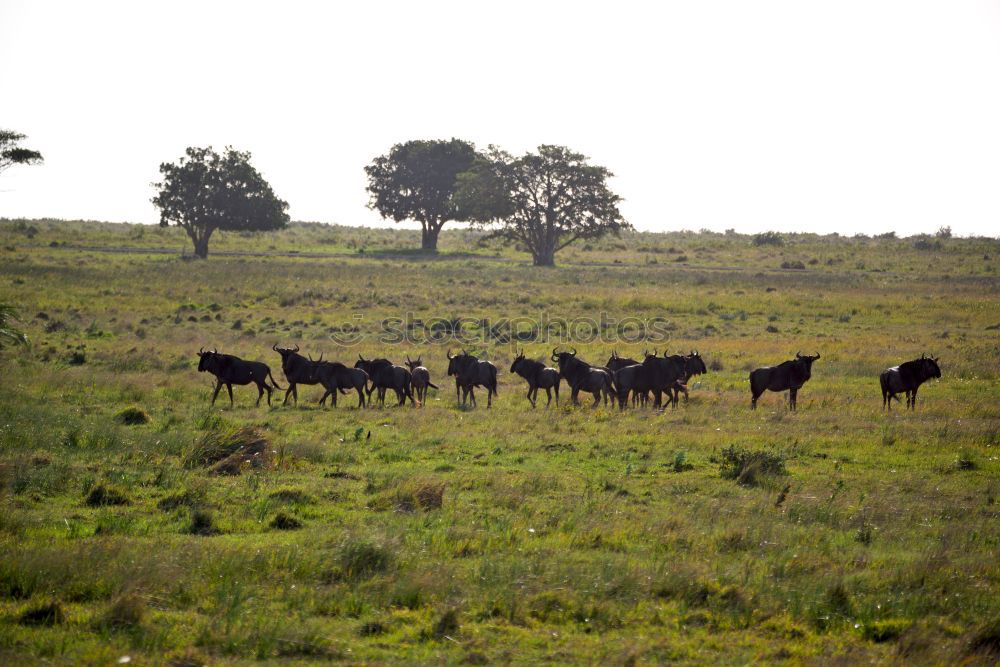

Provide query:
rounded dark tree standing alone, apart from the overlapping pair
left=152, top=146, right=288, bottom=259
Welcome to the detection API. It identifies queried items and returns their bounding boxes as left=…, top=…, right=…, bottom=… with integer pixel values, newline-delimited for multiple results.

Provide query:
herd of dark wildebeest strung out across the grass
left=198, top=344, right=941, bottom=411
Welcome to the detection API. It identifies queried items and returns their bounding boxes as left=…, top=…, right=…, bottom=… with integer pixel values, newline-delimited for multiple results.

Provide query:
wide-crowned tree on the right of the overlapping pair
left=455, top=145, right=632, bottom=266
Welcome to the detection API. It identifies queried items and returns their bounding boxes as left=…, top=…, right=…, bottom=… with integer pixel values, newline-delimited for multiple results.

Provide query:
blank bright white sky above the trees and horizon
left=0, top=0, right=1000, bottom=236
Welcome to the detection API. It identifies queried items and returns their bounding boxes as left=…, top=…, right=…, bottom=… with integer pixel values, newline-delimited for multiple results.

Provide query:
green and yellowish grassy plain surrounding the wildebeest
left=0, top=221, right=1000, bottom=665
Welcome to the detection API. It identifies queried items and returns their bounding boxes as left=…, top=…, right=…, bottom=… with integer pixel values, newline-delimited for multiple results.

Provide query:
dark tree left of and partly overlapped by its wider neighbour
left=365, top=139, right=476, bottom=250
